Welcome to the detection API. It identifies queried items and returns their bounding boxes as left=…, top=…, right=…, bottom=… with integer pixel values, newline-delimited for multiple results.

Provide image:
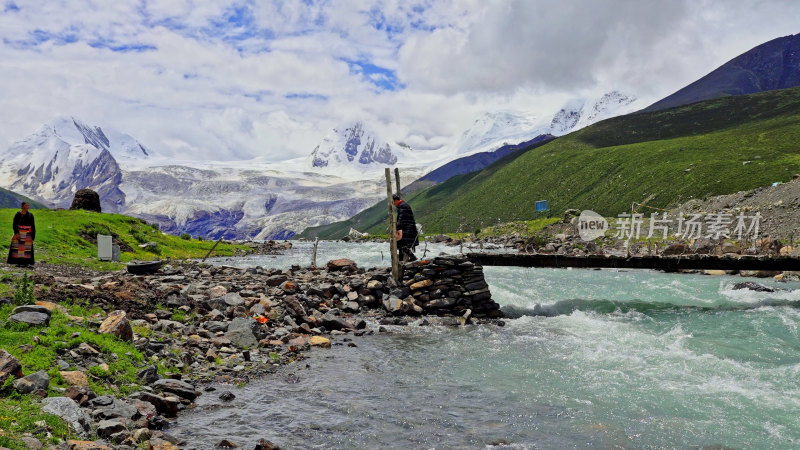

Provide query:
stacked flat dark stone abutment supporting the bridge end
left=387, top=255, right=503, bottom=318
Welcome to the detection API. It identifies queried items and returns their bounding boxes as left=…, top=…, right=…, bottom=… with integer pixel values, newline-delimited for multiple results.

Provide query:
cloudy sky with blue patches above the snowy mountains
left=0, top=0, right=800, bottom=161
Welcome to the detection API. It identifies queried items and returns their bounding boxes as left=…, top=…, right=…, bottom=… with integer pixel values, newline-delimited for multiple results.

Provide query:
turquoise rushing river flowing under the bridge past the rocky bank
left=170, top=242, right=800, bottom=449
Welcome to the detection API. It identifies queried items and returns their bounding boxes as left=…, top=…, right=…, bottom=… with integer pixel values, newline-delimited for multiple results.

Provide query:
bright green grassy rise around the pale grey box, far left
left=0, top=209, right=250, bottom=270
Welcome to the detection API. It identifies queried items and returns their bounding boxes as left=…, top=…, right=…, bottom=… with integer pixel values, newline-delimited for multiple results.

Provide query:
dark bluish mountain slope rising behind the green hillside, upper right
left=644, top=34, right=800, bottom=111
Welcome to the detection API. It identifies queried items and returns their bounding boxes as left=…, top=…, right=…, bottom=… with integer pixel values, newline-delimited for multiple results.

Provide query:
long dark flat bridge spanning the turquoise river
left=465, top=253, right=800, bottom=272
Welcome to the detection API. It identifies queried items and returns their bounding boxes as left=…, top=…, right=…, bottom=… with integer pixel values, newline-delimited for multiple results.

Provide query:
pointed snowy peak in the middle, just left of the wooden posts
left=308, top=122, right=406, bottom=172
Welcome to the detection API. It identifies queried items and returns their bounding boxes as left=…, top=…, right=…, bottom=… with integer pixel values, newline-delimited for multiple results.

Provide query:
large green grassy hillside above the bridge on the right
left=310, top=88, right=800, bottom=237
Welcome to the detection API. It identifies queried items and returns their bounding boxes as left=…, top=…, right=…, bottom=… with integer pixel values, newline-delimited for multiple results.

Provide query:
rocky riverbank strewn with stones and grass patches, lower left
left=0, top=258, right=502, bottom=448
